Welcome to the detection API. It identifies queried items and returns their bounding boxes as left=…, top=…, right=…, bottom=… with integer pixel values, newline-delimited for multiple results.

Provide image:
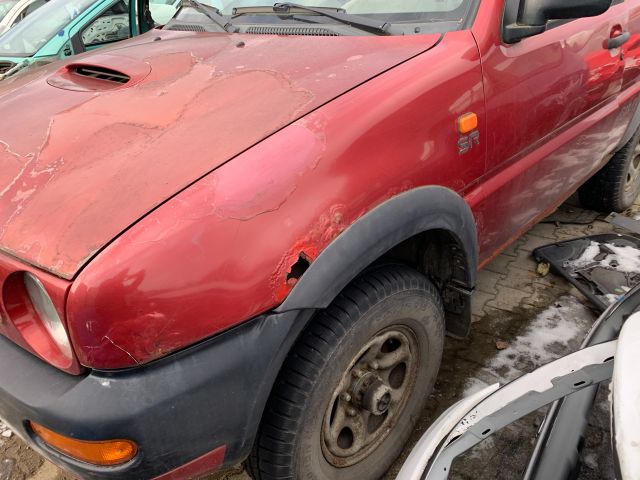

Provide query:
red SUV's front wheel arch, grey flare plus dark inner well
left=275, top=186, right=478, bottom=337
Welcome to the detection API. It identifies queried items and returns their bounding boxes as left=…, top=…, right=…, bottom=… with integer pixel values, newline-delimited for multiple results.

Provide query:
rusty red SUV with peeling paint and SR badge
left=0, top=0, right=640, bottom=480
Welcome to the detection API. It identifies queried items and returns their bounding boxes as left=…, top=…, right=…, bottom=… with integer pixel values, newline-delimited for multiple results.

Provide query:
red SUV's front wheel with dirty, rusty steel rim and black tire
left=248, top=265, right=444, bottom=480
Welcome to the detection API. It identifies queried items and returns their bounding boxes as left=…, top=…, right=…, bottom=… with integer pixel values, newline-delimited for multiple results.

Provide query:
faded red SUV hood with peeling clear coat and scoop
left=0, top=31, right=439, bottom=279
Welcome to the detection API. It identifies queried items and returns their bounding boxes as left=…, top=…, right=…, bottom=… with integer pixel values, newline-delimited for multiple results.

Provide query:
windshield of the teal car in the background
left=0, top=0, right=96, bottom=57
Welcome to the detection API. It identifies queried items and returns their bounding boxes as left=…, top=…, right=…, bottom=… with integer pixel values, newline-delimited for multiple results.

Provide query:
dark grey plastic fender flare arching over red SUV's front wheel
left=276, top=186, right=478, bottom=312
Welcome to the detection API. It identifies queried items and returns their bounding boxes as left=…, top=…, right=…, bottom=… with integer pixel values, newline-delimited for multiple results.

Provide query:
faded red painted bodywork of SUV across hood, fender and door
left=0, top=0, right=640, bottom=369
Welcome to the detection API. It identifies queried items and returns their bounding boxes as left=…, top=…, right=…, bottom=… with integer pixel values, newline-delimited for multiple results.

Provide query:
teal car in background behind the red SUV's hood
left=0, top=0, right=181, bottom=80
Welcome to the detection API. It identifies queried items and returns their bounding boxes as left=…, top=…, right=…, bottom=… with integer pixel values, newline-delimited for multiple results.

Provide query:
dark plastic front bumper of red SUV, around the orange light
left=0, top=312, right=312, bottom=479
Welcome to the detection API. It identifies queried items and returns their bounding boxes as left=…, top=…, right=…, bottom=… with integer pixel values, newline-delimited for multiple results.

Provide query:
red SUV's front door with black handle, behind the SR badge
left=472, top=0, right=632, bottom=261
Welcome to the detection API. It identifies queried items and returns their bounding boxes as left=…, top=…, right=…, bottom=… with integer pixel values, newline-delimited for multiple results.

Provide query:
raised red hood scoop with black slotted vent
left=47, top=54, right=151, bottom=92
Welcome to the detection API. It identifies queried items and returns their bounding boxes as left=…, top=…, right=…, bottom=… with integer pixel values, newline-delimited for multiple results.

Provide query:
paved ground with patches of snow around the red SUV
left=0, top=198, right=640, bottom=480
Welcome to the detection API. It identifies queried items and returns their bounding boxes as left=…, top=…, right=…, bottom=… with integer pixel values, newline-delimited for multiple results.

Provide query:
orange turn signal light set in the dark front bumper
left=29, top=422, right=138, bottom=466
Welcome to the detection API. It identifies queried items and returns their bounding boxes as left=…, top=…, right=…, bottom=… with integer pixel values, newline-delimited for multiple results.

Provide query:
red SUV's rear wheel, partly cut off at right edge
left=578, top=129, right=640, bottom=213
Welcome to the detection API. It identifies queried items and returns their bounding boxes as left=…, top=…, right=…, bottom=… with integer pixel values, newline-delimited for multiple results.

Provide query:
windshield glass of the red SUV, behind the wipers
left=212, top=0, right=472, bottom=22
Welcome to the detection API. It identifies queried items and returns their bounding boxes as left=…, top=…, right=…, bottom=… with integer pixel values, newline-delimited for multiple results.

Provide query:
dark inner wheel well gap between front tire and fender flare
left=374, top=229, right=474, bottom=337
